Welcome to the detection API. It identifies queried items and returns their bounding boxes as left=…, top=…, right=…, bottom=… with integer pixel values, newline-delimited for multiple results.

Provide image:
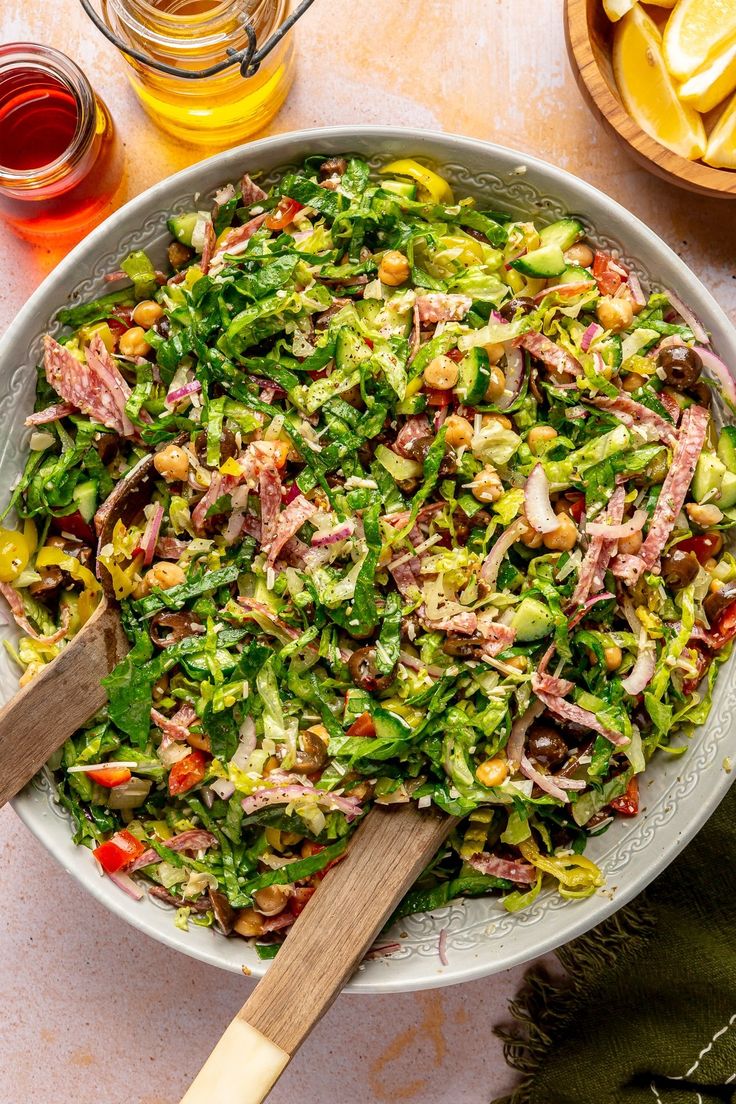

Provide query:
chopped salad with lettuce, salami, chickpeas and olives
left=0, top=157, right=736, bottom=957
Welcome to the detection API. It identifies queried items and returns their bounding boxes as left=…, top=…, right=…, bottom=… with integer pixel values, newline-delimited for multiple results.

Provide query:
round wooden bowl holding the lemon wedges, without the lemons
left=565, top=0, right=736, bottom=199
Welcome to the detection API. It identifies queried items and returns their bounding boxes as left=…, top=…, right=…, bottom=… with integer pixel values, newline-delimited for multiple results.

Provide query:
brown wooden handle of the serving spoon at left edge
left=0, top=599, right=130, bottom=807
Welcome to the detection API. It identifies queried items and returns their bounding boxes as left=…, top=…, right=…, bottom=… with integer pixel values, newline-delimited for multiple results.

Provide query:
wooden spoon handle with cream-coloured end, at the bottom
left=182, top=804, right=456, bottom=1104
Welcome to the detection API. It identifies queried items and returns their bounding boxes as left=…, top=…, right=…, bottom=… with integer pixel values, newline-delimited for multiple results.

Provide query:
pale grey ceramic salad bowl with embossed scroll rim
left=0, top=127, right=736, bottom=992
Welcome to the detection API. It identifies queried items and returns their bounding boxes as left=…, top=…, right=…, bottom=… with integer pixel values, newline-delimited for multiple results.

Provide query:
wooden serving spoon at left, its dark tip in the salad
left=0, top=446, right=160, bottom=808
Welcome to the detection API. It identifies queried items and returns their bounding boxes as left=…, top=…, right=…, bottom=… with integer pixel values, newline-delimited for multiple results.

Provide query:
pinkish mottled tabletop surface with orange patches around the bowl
left=0, top=0, right=736, bottom=1104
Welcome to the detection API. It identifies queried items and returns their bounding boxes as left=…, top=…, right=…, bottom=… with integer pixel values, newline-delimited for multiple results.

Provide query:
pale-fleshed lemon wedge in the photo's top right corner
left=663, top=0, right=736, bottom=81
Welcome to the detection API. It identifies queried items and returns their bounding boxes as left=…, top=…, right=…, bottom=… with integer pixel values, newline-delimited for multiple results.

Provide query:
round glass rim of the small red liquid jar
left=0, top=42, right=95, bottom=189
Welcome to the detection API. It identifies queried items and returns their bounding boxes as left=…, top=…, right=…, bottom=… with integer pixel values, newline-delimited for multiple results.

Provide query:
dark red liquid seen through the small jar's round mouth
left=0, top=68, right=78, bottom=171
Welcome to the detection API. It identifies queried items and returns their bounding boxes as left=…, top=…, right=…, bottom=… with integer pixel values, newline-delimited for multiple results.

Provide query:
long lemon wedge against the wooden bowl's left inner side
left=614, top=0, right=706, bottom=161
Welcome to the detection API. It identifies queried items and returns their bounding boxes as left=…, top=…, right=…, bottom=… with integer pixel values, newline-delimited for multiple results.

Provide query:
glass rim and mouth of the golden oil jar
left=103, top=0, right=288, bottom=52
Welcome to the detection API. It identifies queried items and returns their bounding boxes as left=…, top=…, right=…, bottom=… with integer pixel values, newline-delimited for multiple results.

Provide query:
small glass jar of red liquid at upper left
left=0, top=42, right=122, bottom=246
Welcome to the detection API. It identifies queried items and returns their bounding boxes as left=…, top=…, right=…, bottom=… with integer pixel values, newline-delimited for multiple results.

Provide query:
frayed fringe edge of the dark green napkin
left=492, top=894, right=655, bottom=1104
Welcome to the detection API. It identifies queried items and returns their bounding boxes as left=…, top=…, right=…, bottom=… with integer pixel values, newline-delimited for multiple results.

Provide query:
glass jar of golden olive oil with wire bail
left=102, top=0, right=294, bottom=147
